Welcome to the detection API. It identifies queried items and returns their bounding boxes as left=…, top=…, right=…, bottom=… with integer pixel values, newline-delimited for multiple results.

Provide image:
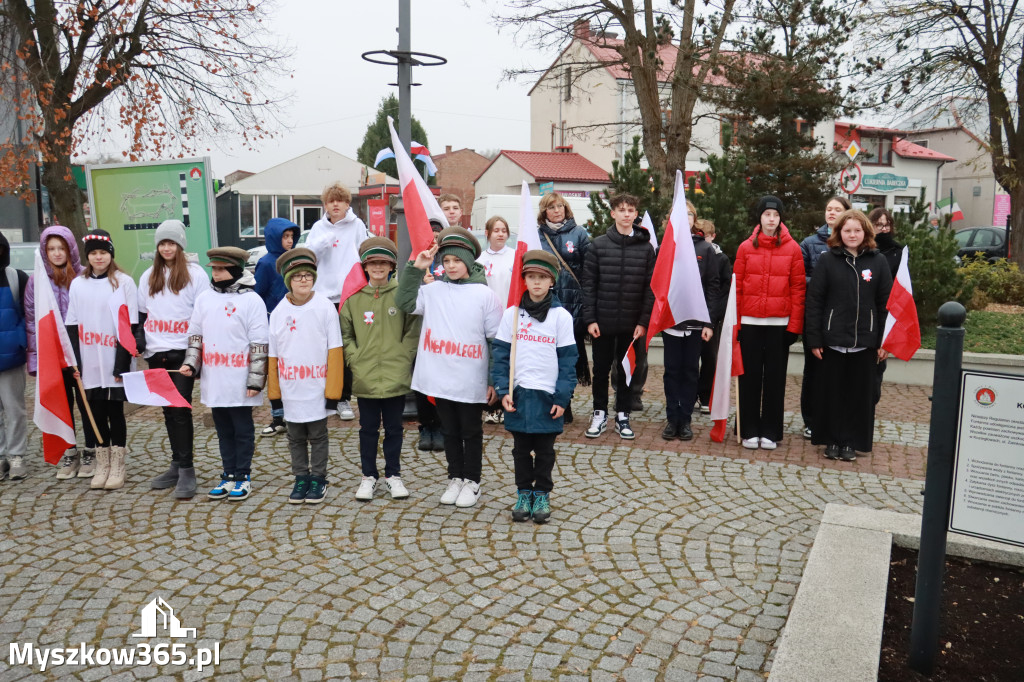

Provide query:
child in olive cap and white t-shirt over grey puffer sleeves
left=181, top=247, right=269, bottom=502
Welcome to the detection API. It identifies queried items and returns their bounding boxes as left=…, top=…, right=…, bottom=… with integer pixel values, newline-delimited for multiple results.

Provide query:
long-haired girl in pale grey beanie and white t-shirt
left=138, top=220, right=210, bottom=500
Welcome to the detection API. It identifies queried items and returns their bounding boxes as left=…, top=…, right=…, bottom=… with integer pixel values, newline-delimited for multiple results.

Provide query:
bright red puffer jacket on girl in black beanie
left=732, top=224, right=807, bottom=334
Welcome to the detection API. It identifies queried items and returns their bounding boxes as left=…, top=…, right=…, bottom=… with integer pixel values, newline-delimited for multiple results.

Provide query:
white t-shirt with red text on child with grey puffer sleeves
left=188, top=288, right=270, bottom=408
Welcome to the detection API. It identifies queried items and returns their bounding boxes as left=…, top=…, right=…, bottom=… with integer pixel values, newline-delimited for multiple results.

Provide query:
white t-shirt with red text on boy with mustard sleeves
left=270, top=292, right=341, bottom=424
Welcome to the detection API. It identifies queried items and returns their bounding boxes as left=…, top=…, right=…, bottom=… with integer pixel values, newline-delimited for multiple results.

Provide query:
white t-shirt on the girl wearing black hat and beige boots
left=65, top=272, right=138, bottom=389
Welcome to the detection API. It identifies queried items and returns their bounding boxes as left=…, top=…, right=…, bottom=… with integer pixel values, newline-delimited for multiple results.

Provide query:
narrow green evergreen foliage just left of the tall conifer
left=686, top=130, right=752, bottom=260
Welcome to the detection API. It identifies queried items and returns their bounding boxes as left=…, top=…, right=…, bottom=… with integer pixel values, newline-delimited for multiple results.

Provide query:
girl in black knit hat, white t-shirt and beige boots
left=65, top=229, right=138, bottom=491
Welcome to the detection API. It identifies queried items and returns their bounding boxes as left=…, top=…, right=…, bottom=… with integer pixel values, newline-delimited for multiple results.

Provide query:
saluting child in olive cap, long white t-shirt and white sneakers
left=395, top=227, right=503, bottom=507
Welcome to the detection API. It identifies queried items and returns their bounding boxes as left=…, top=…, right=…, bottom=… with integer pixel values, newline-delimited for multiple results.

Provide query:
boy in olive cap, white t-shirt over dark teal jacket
left=490, top=250, right=579, bottom=523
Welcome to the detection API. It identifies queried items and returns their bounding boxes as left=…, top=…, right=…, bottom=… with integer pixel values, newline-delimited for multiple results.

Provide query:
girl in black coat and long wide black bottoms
left=804, top=210, right=893, bottom=462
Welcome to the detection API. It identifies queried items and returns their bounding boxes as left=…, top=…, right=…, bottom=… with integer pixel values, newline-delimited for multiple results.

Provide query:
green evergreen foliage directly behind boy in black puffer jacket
left=587, top=135, right=673, bottom=239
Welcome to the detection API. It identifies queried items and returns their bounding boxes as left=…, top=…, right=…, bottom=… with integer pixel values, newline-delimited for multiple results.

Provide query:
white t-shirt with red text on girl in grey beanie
left=138, top=263, right=210, bottom=357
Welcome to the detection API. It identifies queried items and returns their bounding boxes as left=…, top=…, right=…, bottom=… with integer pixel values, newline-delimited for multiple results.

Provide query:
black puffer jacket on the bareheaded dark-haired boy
left=583, top=227, right=655, bottom=335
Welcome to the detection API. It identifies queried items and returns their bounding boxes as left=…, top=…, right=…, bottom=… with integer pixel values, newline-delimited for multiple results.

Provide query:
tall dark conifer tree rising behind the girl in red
left=716, top=0, right=851, bottom=240
